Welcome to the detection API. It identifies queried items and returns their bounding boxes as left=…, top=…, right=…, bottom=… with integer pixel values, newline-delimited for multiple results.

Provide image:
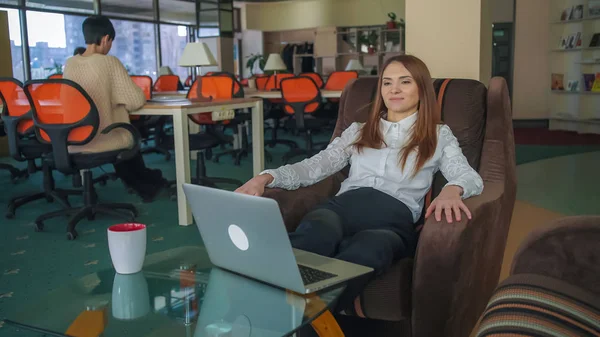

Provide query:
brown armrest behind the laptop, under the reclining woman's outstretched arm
left=263, top=172, right=344, bottom=232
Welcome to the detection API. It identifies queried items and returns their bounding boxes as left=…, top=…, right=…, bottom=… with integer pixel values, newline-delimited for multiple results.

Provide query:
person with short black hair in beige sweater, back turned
left=63, top=16, right=167, bottom=202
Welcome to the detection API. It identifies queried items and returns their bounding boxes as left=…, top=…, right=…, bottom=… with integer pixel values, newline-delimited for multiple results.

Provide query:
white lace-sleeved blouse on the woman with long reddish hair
left=261, top=112, right=483, bottom=222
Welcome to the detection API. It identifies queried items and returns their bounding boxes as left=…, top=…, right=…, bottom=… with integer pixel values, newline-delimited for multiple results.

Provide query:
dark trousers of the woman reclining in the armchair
left=289, top=188, right=418, bottom=311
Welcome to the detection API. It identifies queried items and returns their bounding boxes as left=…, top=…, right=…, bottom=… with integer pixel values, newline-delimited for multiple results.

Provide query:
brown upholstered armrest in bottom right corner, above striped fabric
left=511, top=216, right=600, bottom=293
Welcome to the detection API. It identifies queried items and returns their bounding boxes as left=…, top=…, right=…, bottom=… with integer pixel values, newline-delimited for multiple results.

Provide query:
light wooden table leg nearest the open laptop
left=173, top=111, right=193, bottom=226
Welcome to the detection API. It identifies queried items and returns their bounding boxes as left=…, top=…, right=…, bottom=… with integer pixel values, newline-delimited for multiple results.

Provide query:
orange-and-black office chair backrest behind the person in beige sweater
left=24, top=79, right=100, bottom=172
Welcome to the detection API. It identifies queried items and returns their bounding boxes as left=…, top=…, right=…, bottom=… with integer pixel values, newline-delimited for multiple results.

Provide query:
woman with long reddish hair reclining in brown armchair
left=237, top=55, right=483, bottom=309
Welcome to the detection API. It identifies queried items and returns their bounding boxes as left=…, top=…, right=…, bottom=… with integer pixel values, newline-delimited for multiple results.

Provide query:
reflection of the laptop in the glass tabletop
left=194, top=268, right=306, bottom=337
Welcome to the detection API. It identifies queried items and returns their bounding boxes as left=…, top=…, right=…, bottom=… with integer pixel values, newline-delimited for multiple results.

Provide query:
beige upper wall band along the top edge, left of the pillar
left=242, top=0, right=404, bottom=31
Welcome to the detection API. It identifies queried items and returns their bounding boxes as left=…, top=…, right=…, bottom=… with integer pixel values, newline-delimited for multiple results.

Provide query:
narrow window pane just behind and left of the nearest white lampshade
left=160, top=24, right=188, bottom=83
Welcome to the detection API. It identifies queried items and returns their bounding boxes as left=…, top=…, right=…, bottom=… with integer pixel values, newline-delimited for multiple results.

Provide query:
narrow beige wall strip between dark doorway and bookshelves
left=512, top=0, right=550, bottom=119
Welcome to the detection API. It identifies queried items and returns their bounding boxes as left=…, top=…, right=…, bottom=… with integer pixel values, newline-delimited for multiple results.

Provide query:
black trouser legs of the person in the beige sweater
left=114, top=153, right=167, bottom=200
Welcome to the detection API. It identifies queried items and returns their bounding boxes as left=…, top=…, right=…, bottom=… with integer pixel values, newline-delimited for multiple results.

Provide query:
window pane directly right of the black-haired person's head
left=110, top=19, right=156, bottom=80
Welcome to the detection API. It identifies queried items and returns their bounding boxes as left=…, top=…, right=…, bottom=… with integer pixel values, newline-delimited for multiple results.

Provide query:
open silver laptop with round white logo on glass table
left=183, top=184, right=373, bottom=294
